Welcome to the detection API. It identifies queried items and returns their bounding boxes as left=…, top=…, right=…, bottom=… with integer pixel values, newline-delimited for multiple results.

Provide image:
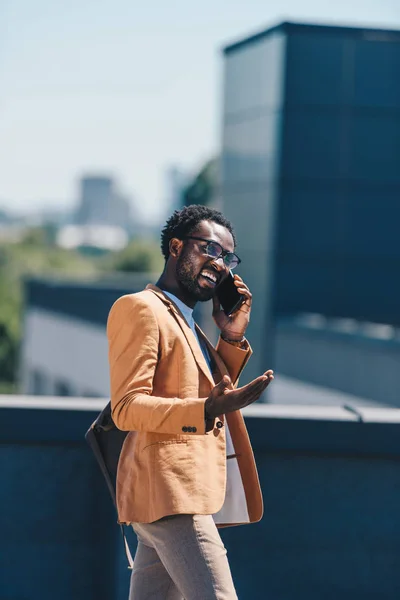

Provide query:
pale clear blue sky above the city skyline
left=0, top=0, right=400, bottom=221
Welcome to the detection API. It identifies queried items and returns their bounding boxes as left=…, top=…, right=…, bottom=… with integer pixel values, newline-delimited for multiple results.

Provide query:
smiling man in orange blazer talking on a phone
left=107, top=205, right=273, bottom=600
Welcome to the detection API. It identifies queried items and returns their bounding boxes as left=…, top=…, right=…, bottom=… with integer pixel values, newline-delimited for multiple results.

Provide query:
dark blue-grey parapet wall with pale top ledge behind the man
left=0, top=397, right=400, bottom=600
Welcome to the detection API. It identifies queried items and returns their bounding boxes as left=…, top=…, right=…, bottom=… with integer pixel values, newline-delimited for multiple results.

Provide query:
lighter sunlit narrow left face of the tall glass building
left=222, top=32, right=285, bottom=380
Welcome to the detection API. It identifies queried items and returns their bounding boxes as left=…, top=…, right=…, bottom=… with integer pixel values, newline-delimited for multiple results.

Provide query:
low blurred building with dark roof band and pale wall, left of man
left=19, top=274, right=154, bottom=397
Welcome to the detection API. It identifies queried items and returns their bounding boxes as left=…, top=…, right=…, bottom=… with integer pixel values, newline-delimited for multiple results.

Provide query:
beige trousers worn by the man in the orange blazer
left=129, top=515, right=237, bottom=600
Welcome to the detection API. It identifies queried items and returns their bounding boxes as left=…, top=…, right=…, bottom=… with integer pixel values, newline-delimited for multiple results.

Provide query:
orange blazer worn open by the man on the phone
left=107, top=285, right=263, bottom=523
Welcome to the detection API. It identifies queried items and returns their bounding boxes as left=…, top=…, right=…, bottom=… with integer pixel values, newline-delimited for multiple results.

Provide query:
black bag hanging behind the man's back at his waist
left=85, top=402, right=133, bottom=569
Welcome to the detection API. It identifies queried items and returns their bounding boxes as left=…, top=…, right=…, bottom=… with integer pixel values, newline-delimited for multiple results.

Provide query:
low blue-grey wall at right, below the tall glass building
left=275, top=317, right=400, bottom=407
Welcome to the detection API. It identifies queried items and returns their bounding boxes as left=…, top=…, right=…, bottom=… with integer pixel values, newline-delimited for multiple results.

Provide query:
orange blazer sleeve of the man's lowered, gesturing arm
left=107, top=295, right=206, bottom=435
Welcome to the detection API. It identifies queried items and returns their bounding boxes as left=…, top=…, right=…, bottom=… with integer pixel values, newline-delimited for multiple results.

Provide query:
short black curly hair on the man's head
left=161, top=204, right=236, bottom=260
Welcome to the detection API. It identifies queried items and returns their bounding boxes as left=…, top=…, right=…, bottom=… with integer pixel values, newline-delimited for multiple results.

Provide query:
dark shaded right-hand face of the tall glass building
left=274, top=27, right=400, bottom=324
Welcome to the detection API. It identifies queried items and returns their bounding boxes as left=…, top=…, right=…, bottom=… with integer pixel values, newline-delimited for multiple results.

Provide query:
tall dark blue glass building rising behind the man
left=221, top=23, right=400, bottom=380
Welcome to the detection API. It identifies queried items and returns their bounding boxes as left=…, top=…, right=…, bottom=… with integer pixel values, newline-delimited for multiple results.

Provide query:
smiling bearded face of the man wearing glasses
left=176, top=221, right=234, bottom=302
